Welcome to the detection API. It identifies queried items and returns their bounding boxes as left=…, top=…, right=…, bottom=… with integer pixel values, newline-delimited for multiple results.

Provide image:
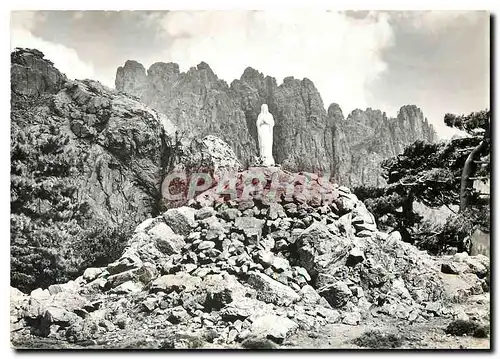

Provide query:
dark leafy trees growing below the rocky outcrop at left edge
left=10, top=95, right=128, bottom=292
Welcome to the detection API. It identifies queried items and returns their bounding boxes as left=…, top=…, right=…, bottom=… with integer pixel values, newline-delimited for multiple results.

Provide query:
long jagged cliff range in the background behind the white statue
left=116, top=61, right=435, bottom=186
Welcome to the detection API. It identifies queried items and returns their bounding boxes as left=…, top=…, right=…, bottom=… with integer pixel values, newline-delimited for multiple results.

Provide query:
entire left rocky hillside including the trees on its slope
left=11, top=49, right=239, bottom=290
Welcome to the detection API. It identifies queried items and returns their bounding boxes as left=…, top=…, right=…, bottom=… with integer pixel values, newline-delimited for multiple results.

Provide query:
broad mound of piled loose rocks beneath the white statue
left=11, top=169, right=489, bottom=345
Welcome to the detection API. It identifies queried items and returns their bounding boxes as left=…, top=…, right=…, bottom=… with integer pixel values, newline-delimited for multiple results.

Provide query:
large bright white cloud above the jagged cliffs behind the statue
left=156, top=10, right=393, bottom=114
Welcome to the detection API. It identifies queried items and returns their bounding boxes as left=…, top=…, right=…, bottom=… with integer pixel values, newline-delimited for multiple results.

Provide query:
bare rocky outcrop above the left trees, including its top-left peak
left=12, top=50, right=169, bottom=233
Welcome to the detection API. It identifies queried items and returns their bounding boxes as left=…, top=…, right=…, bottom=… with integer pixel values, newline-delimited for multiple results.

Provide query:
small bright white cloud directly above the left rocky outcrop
left=10, top=11, right=103, bottom=87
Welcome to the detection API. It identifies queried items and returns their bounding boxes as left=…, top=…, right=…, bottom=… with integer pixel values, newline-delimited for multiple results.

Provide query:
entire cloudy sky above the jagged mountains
left=11, top=10, right=490, bottom=137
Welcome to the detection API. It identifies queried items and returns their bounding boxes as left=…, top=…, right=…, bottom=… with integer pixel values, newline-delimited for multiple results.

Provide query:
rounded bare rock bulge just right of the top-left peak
left=54, top=81, right=169, bottom=223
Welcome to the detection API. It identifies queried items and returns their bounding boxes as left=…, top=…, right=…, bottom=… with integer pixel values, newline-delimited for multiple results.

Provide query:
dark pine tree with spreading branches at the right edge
left=354, top=110, right=491, bottom=251
